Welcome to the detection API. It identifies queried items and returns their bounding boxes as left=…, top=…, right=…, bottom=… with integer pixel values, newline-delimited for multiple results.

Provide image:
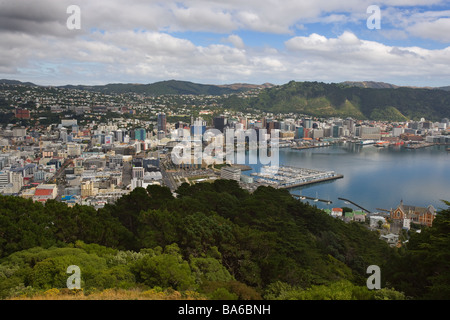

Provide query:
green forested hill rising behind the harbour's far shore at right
left=224, top=81, right=450, bottom=121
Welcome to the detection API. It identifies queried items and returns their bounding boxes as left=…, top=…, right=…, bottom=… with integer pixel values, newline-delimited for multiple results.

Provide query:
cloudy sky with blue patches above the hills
left=0, top=0, right=450, bottom=87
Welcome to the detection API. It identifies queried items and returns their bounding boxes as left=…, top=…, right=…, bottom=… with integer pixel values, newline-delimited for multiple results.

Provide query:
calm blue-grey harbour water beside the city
left=243, top=143, right=450, bottom=212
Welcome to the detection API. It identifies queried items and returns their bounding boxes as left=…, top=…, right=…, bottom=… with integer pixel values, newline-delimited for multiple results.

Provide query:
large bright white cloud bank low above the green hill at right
left=286, top=32, right=450, bottom=84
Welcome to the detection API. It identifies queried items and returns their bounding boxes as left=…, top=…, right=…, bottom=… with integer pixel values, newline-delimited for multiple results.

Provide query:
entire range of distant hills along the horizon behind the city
left=0, top=80, right=450, bottom=121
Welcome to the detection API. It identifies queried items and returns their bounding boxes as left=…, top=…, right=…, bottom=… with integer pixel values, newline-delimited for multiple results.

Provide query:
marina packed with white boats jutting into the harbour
left=251, top=166, right=344, bottom=189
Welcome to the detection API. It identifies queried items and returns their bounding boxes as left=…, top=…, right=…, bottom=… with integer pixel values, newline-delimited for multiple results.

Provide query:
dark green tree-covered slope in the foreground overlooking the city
left=0, top=180, right=450, bottom=300
